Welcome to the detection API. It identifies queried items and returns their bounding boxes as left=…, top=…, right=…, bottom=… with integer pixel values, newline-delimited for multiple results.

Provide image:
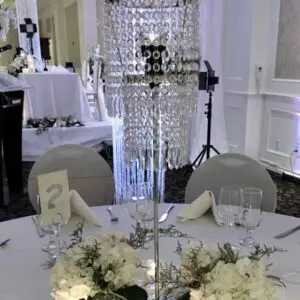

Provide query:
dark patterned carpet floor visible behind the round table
left=0, top=152, right=300, bottom=222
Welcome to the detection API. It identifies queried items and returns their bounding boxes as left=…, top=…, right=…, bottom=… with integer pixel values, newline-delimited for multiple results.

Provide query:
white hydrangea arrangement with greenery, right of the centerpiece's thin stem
left=160, top=242, right=283, bottom=300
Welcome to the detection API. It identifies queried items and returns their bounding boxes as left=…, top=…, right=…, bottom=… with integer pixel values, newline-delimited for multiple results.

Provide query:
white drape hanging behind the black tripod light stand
left=189, top=0, right=228, bottom=162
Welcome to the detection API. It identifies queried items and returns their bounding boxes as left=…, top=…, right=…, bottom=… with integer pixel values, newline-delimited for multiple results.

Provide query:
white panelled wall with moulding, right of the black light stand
left=224, top=0, right=300, bottom=173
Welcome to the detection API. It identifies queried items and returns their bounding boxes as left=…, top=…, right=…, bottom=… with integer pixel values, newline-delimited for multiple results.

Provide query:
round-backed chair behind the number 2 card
left=28, top=145, right=114, bottom=209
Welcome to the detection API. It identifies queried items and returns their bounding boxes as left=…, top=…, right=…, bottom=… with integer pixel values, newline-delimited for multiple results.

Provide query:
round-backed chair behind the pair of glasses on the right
left=185, top=153, right=277, bottom=212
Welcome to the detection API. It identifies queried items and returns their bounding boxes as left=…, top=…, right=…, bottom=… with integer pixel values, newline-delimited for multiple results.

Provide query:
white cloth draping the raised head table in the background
left=20, top=72, right=94, bottom=122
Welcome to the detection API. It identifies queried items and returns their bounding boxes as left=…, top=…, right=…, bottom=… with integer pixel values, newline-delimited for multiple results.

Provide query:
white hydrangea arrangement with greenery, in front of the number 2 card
left=51, top=233, right=147, bottom=300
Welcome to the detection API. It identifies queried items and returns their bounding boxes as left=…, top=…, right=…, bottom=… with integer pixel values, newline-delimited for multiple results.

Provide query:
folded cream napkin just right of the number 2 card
left=69, top=190, right=102, bottom=226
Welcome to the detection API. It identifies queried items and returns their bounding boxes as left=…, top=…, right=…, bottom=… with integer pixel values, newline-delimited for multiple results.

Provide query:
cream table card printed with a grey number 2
left=37, top=170, right=71, bottom=225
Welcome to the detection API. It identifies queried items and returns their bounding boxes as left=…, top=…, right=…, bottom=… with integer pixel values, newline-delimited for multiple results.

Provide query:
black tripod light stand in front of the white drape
left=192, top=60, right=220, bottom=168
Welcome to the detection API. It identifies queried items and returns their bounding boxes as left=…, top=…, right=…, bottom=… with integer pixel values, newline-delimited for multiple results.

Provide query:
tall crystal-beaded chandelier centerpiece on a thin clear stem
left=104, top=0, right=200, bottom=299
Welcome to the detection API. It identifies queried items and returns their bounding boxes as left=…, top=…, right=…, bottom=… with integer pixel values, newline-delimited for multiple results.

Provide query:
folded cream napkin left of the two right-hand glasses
left=177, top=191, right=222, bottom=225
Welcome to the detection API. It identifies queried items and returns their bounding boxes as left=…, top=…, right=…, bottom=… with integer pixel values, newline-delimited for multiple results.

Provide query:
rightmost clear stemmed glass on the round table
left=239, top=187, right=263, bottom=247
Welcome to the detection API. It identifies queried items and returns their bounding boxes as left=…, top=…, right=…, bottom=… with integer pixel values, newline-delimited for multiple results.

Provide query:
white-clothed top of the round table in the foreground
left=0, top=204, right=300, bottom=300
